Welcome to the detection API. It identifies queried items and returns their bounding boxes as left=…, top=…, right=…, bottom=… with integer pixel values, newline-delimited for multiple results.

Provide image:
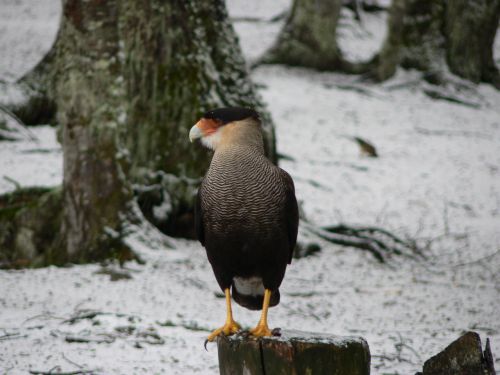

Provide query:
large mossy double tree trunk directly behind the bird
left=0, top=0, right=276, bottom=265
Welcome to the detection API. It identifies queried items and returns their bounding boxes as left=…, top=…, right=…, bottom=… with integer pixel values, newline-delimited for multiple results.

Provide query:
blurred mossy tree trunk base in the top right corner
left=373, top=0, right=500, bottom=87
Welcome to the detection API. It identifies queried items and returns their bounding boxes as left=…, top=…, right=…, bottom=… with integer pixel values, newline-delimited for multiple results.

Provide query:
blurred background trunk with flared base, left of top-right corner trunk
left=260, top=0, right=367, bottom=73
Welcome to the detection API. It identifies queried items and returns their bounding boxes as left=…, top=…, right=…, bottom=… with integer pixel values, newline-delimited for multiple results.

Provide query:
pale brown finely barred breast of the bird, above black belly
left=201, top=146, right=286, bottom=234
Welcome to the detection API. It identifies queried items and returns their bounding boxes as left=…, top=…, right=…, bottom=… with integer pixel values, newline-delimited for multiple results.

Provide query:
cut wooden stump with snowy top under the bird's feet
left=217, top=330, right=370, bottom=375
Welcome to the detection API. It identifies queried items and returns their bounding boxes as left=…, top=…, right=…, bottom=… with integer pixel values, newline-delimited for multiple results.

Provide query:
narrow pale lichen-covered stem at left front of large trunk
left=55, top=0, right=131, bottom=261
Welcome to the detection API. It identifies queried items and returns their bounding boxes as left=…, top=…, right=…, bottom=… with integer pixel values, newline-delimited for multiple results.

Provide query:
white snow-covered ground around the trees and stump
left=0, top=0, right=500, bottom=375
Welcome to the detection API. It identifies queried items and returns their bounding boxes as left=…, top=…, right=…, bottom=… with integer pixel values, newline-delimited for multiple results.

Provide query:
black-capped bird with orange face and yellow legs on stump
left=189, top=107, right=299, bottom=344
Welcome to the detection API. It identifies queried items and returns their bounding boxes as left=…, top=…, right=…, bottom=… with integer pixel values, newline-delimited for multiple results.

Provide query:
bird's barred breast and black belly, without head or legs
left=200, top=145, right=293, bottom=309
